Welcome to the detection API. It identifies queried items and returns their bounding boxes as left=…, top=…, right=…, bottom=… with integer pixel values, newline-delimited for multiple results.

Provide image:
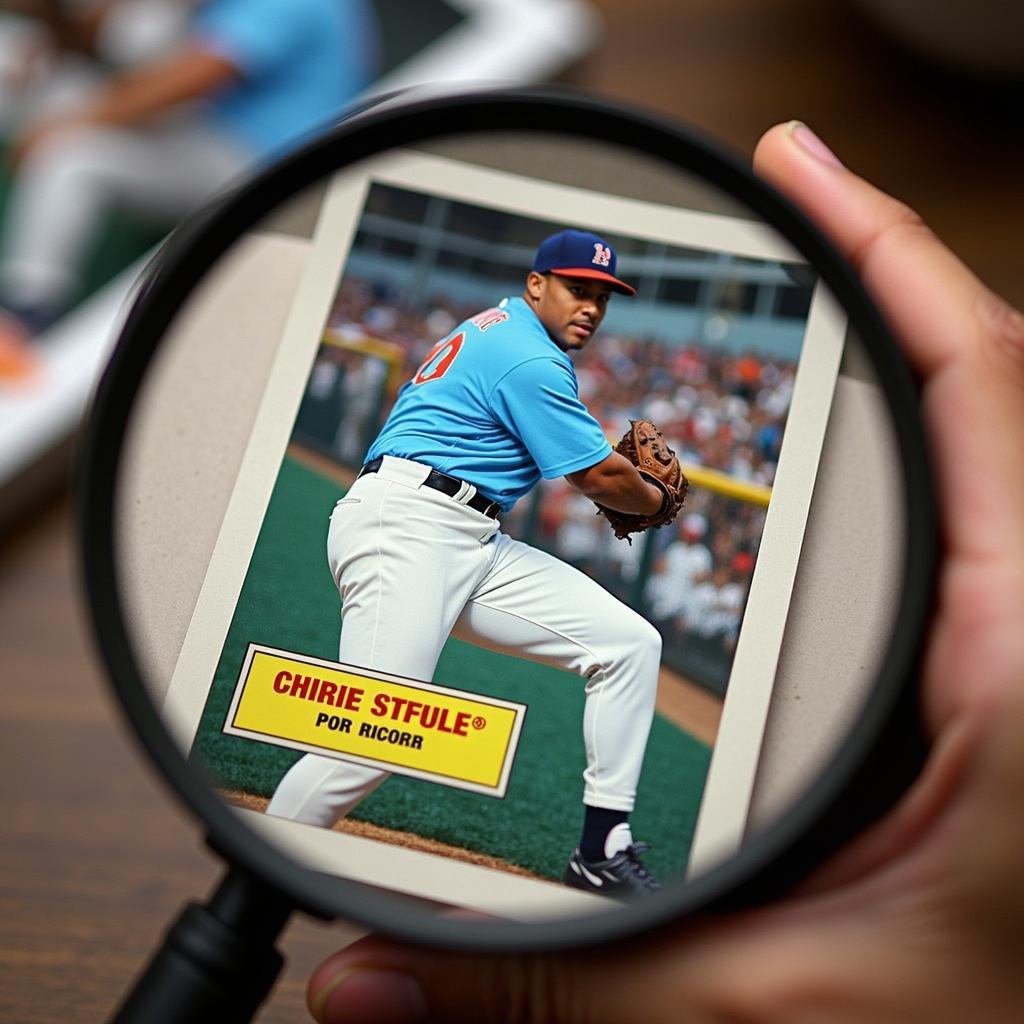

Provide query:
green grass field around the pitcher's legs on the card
left=195, top=459, right=711, bottom=878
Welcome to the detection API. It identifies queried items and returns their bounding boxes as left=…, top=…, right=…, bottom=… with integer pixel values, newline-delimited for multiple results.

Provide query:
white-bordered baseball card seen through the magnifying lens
left=155, top=151, right=846, bottom=919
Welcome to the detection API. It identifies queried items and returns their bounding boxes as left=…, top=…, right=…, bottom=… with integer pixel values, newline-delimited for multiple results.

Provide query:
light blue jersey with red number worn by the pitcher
left=367, top=298, right=611, bottom=512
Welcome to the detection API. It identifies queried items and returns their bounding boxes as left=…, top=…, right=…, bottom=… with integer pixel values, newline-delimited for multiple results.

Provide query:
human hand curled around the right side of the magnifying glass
left=308, top=123, right=1024, bottom=1024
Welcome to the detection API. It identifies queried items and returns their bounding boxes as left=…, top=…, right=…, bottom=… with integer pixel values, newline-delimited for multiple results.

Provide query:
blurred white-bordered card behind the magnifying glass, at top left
left=0, top=0, right=597, bottom=529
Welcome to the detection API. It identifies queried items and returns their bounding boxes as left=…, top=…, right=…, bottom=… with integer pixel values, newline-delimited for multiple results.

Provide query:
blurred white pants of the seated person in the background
left=0, top=115, right=252, bottom=309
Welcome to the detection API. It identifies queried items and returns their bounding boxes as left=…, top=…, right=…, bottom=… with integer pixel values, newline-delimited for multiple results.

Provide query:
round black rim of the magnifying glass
left=78, top=89, right=938, bottom=951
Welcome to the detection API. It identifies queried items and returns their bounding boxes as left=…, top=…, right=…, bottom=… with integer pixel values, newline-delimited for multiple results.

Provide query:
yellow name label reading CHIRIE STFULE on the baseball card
left=224, top=644, right=526, bottom=797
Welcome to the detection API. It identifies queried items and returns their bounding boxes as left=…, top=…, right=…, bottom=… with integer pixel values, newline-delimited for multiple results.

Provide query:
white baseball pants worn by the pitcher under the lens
left=267, top=457, right=662, bottom=827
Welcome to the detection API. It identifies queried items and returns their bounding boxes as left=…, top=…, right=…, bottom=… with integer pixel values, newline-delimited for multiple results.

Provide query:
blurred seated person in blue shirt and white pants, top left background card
left=0, top=0, right=378, bottom=364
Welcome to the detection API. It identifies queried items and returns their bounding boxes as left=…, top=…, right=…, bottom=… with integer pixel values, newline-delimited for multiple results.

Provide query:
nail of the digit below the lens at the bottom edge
left=310, top=968, right=427, bottom=1024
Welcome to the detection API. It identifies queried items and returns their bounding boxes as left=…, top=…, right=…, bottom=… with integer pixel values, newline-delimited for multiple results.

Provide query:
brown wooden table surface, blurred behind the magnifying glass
left=0, top=0, right=1024, bottom=1022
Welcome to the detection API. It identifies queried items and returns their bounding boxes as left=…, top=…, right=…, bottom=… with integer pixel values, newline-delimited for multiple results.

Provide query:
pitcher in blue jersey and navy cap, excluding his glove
left=267, top=230, right=664, bottom=898
